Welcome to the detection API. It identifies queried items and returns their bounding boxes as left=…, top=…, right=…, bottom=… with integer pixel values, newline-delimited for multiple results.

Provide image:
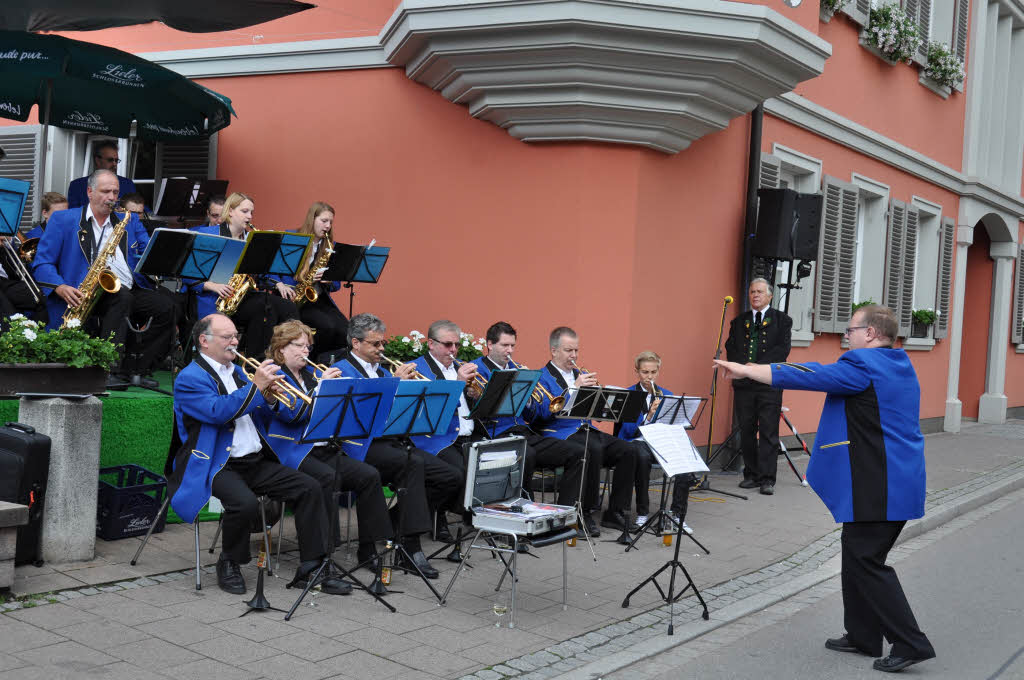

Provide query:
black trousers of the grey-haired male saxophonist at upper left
left=92, top=286, right=174, bottom=372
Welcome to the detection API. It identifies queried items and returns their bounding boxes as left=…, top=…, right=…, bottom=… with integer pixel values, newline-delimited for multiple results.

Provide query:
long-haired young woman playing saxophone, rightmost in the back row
left=283, top=201, right=348, bottom=357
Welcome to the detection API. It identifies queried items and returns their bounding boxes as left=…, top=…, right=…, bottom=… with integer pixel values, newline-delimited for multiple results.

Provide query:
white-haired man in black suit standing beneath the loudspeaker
left=725, top=279, right=793, bottom=496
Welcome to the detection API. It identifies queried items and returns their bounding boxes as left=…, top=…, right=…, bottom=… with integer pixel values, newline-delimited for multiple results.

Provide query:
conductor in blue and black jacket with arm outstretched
left=716, top=305, right=935, bottom=673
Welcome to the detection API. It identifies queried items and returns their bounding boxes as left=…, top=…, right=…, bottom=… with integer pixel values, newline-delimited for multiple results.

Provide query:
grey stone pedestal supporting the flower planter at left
left=17, top=396, right=103, bottom=563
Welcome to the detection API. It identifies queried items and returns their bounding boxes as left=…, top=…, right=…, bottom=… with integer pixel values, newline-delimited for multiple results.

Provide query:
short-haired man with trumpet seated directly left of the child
left=532, top=326, right=637, bottom=536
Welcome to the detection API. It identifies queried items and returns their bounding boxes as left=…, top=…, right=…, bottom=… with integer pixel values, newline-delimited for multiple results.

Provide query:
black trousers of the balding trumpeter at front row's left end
left=213, top=452, right=327, bottom=564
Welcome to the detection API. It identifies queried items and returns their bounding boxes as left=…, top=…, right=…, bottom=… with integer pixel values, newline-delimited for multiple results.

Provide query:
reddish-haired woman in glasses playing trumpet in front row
left=266, top=320, right=394, bottom=573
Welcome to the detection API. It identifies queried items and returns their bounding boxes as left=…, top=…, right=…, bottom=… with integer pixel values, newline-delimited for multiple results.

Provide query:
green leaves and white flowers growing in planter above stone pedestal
left=0, top=314, right=118, bottom=370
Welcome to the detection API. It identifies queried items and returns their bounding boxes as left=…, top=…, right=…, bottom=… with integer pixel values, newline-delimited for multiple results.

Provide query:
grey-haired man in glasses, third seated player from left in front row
left=334, top=313, right=462, bottom=579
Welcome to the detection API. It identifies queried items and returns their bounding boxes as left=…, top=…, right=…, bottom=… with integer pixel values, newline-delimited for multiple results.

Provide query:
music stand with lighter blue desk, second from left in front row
left=379, top=380, right=465, bottom=602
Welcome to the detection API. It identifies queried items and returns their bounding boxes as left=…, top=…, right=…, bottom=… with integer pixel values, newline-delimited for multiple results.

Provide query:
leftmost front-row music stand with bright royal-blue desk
left=285, top=378, right=400, bottom=621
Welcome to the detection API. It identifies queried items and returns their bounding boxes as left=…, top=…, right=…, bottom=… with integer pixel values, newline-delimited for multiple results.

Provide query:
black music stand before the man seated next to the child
left=555, top=385, right=646, bottom=562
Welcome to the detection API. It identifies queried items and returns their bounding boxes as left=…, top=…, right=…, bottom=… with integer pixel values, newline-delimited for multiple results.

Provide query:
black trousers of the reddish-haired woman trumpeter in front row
left=299, top=447, right=394, bottom=546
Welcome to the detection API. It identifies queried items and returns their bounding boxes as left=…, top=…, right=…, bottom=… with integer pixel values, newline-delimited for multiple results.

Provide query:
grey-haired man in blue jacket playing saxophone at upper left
left=33, top=170, right=172, bottom=387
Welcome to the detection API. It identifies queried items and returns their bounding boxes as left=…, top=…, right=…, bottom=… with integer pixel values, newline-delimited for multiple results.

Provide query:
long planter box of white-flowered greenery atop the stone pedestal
left=0, top=314, right=118, bottom=397
